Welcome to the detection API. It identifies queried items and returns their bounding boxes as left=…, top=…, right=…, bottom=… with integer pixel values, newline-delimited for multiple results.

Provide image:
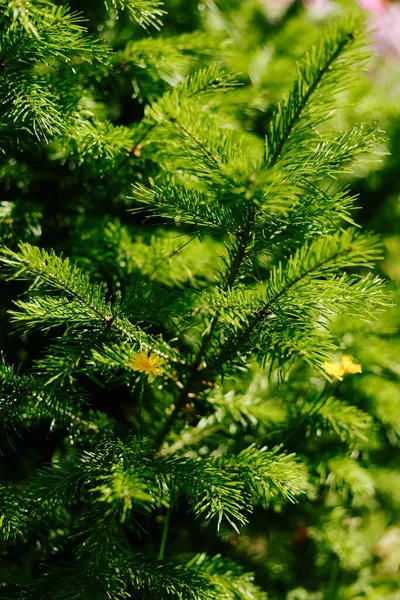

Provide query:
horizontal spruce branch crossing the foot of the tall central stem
left=32, top=437, right=307, bottom=531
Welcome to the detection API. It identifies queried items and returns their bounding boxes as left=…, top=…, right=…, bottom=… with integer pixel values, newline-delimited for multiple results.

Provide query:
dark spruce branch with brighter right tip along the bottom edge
left=35, top=552, right=266, bottom=600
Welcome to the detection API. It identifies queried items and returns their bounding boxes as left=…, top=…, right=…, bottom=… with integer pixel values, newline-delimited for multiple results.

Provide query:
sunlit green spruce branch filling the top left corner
left=0, top=0, right=109, bottom=141
